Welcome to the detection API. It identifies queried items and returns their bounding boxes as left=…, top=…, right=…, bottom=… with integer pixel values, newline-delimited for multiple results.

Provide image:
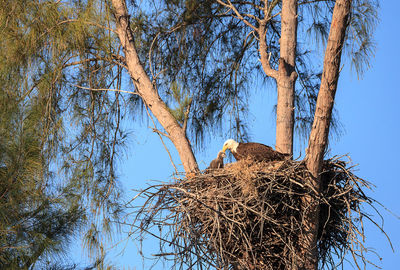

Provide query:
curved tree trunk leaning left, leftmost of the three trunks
left=112, top=0, right=198, bottom=173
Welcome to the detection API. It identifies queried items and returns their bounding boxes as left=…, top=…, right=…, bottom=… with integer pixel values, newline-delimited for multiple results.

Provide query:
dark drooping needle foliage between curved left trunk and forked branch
left=129, top=0, right=258, bottom=146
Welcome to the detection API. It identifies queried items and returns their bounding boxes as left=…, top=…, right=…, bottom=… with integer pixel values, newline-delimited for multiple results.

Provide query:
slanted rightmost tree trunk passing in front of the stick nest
left=300, top=0, right=351, bottom=270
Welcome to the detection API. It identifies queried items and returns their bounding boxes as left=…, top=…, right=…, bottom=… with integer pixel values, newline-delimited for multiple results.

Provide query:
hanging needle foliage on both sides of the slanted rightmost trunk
left=295, top=0, right=379, bottom=143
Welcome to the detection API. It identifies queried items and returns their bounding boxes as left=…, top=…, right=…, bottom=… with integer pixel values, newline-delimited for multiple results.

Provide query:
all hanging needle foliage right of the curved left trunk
left=130, top=0, right=378, bottom=147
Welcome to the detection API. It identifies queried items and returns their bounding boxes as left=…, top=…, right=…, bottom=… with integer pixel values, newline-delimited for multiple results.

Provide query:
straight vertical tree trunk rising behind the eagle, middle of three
left=276, top=0, right=297, bottom=155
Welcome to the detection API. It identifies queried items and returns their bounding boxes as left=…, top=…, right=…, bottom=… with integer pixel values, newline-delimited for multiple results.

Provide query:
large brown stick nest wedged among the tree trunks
left=133, top=159, right=390, bottom=270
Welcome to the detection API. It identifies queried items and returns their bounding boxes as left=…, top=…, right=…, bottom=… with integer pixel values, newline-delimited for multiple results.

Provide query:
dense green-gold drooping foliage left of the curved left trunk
left=0, top=0, right=126, bottom=268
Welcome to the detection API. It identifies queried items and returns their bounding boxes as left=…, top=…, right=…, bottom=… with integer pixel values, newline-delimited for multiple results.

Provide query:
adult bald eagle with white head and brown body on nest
left=222, top=139, right=289, bottom=161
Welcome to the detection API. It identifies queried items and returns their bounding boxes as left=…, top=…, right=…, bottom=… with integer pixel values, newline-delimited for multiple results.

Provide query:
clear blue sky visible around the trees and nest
left=70, top=0, right=400, bottom=270
